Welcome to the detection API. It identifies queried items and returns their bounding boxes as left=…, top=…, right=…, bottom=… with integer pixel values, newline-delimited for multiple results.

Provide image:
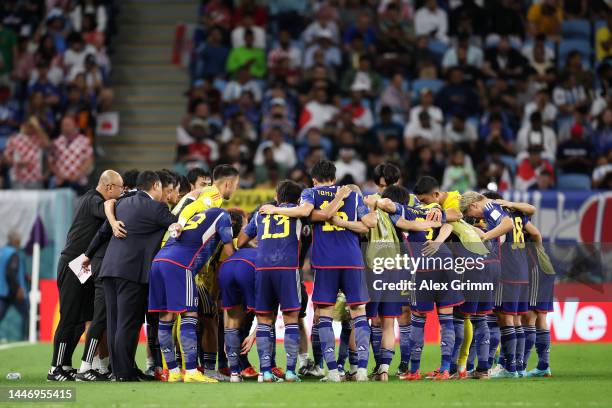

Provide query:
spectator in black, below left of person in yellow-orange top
left=482, top=36, right=527, bottom=80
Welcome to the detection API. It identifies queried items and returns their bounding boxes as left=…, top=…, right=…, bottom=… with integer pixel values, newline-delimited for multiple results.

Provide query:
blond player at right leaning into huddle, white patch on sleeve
left=460, top=191, right=529, bottom=378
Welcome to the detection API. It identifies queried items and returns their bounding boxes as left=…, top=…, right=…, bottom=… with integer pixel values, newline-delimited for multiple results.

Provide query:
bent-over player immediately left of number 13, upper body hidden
left=219, top=248, right=257, bottom=383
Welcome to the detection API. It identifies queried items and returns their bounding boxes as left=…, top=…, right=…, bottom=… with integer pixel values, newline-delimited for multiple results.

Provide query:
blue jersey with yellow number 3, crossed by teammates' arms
left=391, top=203, right=452, bottom=259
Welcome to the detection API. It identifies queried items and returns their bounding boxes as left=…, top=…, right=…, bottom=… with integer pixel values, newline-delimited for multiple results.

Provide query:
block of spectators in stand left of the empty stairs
left=0, top=0, right=117, bottom=193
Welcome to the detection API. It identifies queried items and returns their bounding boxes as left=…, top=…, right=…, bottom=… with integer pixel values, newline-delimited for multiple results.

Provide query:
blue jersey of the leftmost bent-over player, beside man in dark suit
left=153, top=208, right=232, bottom=273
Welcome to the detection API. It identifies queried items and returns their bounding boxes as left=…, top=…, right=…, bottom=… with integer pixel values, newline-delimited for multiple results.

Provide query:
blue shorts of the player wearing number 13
left=255, top=269, right=302, bottom=313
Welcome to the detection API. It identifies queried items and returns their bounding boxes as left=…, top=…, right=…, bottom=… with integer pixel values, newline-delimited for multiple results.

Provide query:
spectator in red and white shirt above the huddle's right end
left=514, top=144, right=555, bottom=191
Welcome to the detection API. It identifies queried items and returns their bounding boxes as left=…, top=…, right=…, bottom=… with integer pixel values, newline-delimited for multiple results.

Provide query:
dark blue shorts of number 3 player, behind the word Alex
left=412, top=271, right=463, bottom=313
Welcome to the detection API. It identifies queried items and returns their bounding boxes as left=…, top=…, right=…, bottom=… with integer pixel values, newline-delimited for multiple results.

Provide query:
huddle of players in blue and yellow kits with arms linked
left=50, top=160, right=554, bottom=383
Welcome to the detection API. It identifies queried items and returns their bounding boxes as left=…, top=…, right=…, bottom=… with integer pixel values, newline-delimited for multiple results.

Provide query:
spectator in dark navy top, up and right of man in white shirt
left=436, top=67, right=480, bottom=117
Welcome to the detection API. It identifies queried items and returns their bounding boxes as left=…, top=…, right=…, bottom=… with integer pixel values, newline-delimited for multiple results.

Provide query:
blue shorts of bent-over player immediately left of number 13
left=219, top=259, right=256, bottom=310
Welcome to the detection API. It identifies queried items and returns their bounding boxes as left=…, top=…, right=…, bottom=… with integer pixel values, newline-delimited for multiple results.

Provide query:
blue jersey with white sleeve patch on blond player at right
left=483, top=202, right=529, bottom=283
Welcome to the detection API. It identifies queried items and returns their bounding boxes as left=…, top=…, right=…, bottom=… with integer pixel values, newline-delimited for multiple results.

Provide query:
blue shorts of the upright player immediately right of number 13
left=312, top=268, right=370, bottom=305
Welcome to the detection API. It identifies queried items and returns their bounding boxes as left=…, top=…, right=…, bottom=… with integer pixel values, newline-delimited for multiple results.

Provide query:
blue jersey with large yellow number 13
left=244, top=204, right=302, bottom=269
